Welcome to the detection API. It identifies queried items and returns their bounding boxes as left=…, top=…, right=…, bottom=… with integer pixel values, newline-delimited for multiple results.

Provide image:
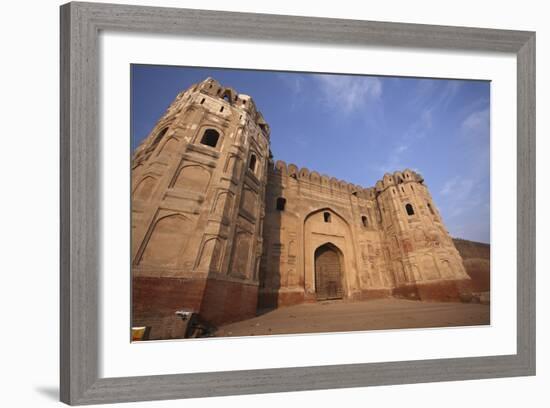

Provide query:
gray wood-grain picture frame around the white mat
left=60, top=3, right=535, bottom=404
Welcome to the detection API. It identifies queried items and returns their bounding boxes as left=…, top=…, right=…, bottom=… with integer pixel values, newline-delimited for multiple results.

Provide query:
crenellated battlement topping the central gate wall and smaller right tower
left=269, top=160, right=424, bottom=200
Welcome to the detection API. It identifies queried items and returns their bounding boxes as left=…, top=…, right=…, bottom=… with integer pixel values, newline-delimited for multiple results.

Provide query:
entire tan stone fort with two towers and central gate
left=132, top=78, right=480, bottom=339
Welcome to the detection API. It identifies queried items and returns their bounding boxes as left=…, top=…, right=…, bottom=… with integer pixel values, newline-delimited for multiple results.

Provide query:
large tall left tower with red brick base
left=132, top=78, right=270, bottom=338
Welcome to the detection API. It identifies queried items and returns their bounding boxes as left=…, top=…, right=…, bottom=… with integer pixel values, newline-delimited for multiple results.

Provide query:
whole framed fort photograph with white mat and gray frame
left=60, top=3, right=535, bottom=405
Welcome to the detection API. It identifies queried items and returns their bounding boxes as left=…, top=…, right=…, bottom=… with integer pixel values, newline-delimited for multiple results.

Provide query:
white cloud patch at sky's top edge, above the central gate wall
left=313, top=75, right=382, bottom=114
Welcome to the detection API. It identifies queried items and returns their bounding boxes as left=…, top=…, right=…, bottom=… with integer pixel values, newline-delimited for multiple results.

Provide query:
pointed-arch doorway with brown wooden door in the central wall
left=315, top=243, right=344, bottom=300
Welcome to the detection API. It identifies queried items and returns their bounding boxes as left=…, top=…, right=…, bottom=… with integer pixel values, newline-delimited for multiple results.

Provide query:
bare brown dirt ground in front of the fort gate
left=214, top=299, right=490, bottom=337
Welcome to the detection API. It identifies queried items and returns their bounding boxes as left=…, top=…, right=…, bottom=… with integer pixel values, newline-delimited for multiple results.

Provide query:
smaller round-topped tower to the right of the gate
left=376, top=170, right=470, bottom=300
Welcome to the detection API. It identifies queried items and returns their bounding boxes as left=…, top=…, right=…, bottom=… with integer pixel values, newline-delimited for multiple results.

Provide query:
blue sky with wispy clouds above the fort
left=131, top=65, right=490, bottom=243
